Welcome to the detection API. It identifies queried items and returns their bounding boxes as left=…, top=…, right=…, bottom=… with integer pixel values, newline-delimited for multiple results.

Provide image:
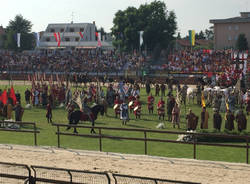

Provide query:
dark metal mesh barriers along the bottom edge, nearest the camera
left=0, top=162, right=198, bottom=184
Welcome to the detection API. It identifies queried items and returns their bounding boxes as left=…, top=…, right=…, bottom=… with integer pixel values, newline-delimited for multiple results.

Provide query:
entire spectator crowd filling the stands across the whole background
left=0, top=49, right=249, bottom=77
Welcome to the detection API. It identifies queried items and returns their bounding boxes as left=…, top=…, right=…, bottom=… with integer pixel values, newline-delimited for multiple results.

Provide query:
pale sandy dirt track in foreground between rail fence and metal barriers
left=0, top=145, right=250, bottom=184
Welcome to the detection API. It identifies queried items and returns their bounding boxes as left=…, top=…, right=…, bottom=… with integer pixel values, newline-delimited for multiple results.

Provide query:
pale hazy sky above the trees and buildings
left=0, top=0, right=250, bottom=37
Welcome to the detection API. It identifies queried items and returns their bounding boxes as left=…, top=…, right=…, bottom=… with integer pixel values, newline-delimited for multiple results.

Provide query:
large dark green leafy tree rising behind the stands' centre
left=111, top=1, right=177, bottom=51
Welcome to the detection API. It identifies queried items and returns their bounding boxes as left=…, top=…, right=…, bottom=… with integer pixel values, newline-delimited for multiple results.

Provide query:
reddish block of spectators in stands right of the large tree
left=151, top=50, right=249, bottom=73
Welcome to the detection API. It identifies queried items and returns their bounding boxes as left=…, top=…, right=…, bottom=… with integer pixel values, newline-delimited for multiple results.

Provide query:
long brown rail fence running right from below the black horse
left=53, top=124, right=250, bottom=164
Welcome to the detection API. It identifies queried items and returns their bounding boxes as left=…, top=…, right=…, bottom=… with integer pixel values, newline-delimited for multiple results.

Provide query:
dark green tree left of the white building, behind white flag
left=4, top=15, right=35, bottom=51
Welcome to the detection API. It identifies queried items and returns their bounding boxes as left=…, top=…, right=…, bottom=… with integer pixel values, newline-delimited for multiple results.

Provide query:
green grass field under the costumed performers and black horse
left=0, top=82, right=250, bottom=162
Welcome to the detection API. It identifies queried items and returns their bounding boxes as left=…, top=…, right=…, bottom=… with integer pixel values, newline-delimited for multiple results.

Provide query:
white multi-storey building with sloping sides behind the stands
left=38, top=22, right=112, bottom=49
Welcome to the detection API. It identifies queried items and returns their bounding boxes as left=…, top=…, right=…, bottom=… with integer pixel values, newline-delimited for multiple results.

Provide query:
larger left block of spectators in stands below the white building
left=0, top=50, right=145, bottom=73
